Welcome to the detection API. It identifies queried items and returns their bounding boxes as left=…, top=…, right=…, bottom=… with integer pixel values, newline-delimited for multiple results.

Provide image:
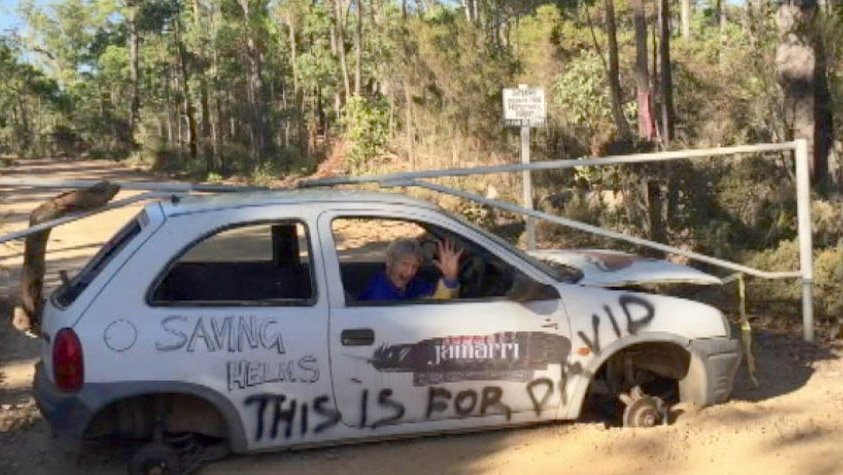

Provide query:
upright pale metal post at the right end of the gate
left=795, top=139, right=814, bottom=342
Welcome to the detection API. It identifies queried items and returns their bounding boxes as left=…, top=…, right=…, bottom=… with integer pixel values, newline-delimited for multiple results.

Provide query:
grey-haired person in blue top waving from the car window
left=359, top=239, right=462, bottom=300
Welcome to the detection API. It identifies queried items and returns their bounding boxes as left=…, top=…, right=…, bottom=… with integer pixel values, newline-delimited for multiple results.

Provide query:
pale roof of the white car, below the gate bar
left=156, top=188, right=438, bottom=216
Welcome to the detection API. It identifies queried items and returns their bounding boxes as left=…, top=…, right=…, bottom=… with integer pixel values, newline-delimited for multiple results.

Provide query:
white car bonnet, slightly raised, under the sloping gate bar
left=530, top=249, right=722, bottom=287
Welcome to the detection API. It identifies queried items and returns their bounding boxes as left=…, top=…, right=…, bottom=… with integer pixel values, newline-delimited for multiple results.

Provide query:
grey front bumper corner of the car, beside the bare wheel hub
left=680, top=338, right=742, bottom=406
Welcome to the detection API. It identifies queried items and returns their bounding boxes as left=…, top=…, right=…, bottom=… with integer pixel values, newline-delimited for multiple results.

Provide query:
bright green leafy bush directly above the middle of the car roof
left=342, top=96, right=389, bottom=172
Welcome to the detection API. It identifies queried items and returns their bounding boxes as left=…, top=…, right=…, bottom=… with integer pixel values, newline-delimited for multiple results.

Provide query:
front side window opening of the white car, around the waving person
left=331, top=217, right=521, bottom=306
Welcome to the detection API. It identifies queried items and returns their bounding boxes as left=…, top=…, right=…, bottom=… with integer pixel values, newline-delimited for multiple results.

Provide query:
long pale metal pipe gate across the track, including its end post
left=0, top=139, right=814, bottom=342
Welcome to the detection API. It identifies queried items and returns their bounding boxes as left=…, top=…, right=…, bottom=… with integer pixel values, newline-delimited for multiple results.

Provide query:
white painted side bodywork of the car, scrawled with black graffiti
left=36, top=191, right=726, bottom=451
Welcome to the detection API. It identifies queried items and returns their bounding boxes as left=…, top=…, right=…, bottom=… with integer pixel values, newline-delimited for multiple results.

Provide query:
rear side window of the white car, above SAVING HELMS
left=149, top=221, right=315, bottom=306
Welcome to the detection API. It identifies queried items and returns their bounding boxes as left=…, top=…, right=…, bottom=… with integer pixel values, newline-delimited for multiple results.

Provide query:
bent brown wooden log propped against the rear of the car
left=12, top=181, right=120, bottom=334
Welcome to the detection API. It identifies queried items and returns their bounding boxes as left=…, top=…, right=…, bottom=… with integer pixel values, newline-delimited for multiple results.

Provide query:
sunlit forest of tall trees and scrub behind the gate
left=0, top=0, right=843, bottom=328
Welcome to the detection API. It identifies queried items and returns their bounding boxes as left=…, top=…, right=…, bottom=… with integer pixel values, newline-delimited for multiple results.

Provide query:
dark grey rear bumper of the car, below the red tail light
left=33, top=362, right=93, bottom=450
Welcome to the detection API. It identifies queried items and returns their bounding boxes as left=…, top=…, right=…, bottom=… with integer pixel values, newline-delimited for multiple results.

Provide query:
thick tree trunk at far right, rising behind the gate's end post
left=776, top=0, right=830, bottom=183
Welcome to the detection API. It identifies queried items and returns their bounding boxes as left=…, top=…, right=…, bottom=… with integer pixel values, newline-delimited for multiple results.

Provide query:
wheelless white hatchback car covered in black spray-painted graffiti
left=35, top=190, right=740, bottom=473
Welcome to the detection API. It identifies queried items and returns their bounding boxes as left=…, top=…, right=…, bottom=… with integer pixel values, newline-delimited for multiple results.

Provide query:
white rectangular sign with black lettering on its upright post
left=503, top=84, right=547, bottom=250
